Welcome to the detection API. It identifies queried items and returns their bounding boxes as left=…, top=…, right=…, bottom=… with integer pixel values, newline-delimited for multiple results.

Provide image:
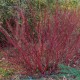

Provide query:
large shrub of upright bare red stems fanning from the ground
left=0, top=7, right=80, bottom=74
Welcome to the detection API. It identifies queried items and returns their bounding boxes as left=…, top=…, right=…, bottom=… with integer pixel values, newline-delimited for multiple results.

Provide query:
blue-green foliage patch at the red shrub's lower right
left=59, top=64, right=80, bottom=80
